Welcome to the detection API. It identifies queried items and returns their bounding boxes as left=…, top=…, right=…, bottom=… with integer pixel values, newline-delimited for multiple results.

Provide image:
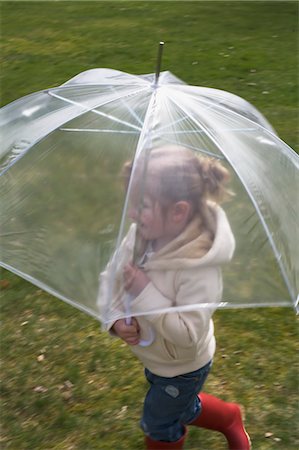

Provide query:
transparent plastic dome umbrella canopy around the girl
left=0, top=69, right=299, bottom=321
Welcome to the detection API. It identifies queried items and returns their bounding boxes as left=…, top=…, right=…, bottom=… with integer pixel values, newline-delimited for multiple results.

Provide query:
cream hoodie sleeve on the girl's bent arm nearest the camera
left=132, top=266, right=222, bottom=348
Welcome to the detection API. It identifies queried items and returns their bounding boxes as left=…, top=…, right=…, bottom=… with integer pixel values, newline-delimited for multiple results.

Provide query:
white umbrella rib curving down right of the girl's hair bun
left=171, top=97, right=296, bottom=303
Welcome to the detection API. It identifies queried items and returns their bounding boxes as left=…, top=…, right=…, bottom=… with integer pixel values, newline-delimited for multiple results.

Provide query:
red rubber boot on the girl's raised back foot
left=189, top=392, right=251, bottom=450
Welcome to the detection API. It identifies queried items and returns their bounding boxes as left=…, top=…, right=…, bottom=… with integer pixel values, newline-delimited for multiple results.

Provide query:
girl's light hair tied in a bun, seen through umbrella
left=124, top=146, right=231, bottom=234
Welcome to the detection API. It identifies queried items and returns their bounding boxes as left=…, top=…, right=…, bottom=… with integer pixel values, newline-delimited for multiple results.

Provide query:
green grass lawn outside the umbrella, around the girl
left=1, top=1, right=299, bottom=450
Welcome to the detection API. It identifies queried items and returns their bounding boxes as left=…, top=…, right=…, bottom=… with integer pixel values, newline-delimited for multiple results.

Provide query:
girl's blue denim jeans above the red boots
left=141, top=361, right=212, bottom=442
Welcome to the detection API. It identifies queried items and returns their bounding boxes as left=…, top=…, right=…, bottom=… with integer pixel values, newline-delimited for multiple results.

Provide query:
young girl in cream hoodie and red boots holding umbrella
left=102, top=147, right=250, bottom=450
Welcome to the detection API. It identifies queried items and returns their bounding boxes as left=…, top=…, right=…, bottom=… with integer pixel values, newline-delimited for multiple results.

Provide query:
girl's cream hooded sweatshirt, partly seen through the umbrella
left=99, top=205, right=235, bottom=377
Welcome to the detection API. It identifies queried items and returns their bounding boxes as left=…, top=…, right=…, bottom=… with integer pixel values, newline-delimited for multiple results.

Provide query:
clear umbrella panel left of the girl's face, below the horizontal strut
left=1, top=125, right=141, bottom=317
